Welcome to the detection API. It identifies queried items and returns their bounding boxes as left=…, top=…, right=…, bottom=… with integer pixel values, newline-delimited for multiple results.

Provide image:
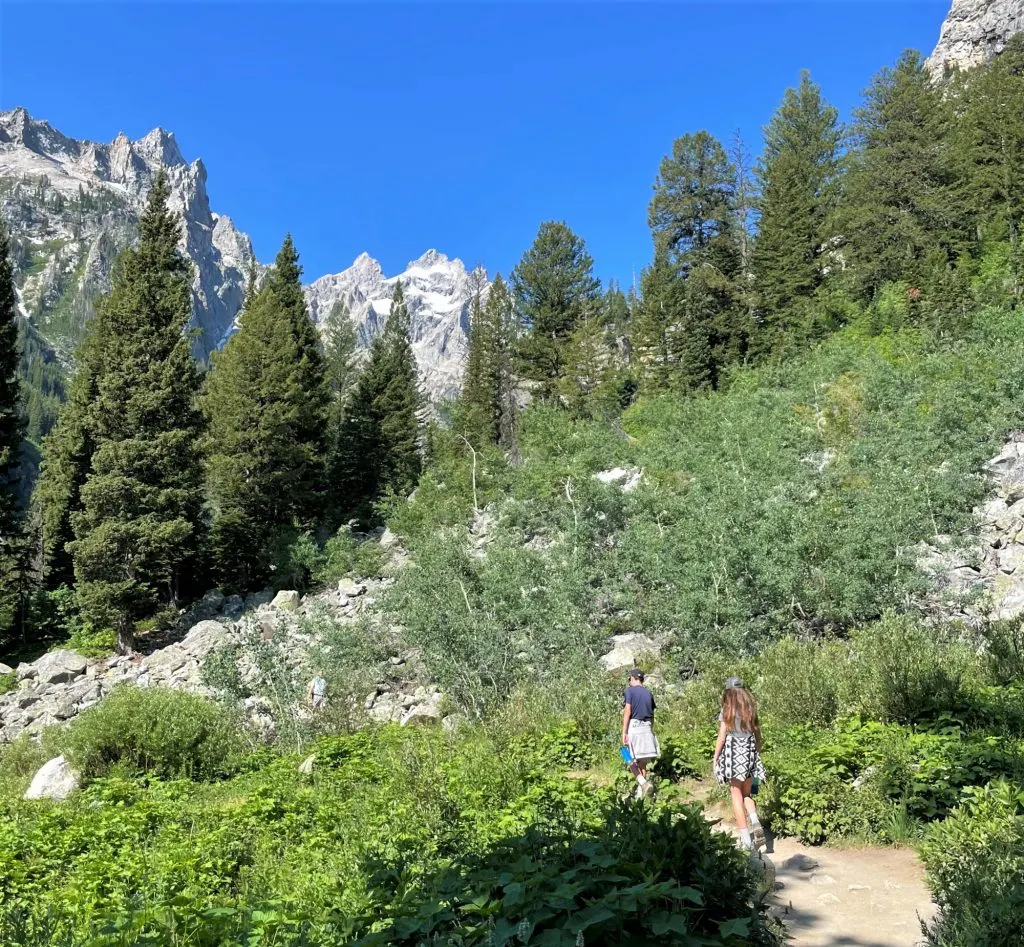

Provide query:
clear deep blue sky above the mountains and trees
left=0, top=0, right=949, bottom=284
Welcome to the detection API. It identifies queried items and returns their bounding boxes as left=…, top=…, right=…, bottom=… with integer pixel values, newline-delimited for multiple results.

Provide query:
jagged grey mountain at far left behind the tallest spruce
left=0, top=109, right=253, bottom=364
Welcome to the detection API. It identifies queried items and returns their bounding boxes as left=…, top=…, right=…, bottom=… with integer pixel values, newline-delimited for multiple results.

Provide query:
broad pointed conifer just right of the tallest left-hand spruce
left=203, top=239, right=330, bottom=590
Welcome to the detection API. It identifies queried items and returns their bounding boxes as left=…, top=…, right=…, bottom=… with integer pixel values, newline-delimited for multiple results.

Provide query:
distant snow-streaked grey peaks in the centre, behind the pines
left=306, top=250, right=488, bottom=399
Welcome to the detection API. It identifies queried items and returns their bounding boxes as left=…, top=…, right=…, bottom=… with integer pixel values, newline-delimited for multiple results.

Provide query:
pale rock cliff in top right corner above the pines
left=928, top=0, right=1024, bottom=76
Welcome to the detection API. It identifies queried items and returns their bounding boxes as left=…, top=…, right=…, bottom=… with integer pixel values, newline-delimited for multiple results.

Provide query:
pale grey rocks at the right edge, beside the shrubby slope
left=919, top=432, right=1024, bottom=626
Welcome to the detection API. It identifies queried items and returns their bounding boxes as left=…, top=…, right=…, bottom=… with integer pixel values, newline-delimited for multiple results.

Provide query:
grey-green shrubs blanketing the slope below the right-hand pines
left=386, top=310, right=1024, bottom=707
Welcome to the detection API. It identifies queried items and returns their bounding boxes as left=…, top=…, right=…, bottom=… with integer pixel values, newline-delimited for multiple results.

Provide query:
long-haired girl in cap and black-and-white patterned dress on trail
left=715, top=678, right=765, bottom=851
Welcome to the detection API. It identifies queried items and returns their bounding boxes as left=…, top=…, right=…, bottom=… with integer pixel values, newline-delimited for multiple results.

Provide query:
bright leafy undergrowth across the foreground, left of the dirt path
left=0, top=707, right=775, bottom=947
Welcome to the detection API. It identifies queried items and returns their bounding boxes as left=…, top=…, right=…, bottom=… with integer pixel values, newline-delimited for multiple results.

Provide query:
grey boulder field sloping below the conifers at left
left=0, top=561, right=442, bottom=743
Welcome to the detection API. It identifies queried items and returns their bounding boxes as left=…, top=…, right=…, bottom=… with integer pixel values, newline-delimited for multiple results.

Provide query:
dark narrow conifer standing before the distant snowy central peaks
left=339, top=283, right=423, bottom=520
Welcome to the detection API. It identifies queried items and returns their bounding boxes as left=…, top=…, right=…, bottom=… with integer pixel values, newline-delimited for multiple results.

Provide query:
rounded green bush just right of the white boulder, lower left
left=57, top=686, right=243, bottom=779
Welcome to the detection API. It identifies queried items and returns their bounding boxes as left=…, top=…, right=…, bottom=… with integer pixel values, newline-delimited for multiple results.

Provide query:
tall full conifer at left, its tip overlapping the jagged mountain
left=70, top=174, right=203, bottom=650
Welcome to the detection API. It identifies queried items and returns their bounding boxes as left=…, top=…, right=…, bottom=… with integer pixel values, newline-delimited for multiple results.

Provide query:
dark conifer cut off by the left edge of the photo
left=0, top=222, right=25, bottom=642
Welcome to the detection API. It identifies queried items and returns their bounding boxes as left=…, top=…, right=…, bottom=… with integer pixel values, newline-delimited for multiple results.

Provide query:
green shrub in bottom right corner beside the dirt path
left=922, top=782, right=1024, bottom=947
